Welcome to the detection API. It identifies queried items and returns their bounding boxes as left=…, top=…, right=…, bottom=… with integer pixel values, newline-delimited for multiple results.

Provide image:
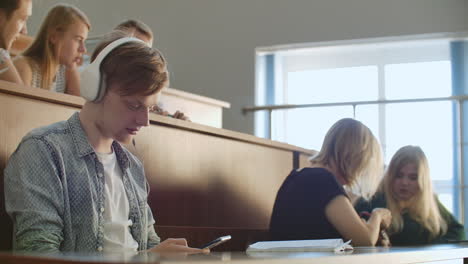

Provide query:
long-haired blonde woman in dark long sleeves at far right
left=355, top=146, right=465, bottom=246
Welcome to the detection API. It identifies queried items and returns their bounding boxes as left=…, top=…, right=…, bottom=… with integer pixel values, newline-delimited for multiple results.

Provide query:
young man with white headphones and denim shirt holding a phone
left=4, top=33, right=206, bottom=253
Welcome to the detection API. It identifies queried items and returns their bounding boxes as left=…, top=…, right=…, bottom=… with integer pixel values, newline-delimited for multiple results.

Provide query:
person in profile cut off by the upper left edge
left=0, top=0, right=32, bottom=84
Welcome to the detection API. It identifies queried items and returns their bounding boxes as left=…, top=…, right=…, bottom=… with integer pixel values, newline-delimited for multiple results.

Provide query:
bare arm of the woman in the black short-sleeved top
left=325, top=195, right=391, bottom=246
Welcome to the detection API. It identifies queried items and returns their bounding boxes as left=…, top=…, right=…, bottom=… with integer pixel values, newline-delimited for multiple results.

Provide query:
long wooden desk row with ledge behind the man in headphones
left=0, top=81, right=314, bottom=250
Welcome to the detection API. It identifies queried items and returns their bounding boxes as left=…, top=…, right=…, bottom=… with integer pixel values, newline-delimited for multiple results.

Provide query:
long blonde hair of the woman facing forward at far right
left=381, top=146, right=447, bottom=240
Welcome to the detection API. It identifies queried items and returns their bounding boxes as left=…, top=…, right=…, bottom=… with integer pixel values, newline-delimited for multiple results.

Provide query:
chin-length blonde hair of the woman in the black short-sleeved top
left=310, top=118, right=383, bottom=199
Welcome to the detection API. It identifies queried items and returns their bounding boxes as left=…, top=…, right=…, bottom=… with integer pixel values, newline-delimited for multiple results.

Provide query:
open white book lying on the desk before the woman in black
left=247, top=238, right=353, bottom=253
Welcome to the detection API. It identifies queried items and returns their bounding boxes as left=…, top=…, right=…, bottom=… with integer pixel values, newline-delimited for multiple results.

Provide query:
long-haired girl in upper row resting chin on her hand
left=15, top=4, right=91, bottom=95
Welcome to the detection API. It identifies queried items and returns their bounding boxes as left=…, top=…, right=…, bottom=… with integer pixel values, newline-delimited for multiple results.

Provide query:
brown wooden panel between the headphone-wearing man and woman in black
left=130, top=126, right=292, bottom=229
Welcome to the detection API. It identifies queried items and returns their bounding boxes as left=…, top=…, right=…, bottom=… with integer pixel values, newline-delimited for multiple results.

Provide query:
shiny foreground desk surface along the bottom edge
left=0, top=244, right=468, bottom=264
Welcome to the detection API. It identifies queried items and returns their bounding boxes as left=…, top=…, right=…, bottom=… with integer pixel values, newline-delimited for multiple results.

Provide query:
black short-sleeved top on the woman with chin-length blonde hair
left=270, top=168, right=346, bottom=240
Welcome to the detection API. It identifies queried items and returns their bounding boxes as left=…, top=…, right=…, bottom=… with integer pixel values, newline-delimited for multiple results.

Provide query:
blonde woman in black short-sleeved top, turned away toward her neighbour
left=270, top=118, right=391, bottom=246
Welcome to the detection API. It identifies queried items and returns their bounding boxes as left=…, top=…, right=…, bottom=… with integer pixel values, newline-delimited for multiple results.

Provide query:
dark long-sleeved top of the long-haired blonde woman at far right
left=354, top=192, right=465, bottom=246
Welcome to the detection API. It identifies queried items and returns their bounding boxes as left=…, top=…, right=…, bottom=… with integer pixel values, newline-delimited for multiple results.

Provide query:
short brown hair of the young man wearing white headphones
left=91, top=30, right=169, bottom=96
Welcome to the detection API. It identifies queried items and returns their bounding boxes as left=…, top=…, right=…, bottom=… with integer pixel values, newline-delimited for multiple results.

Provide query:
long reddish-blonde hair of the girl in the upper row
left=23, top=4, right=91, bottom=89
